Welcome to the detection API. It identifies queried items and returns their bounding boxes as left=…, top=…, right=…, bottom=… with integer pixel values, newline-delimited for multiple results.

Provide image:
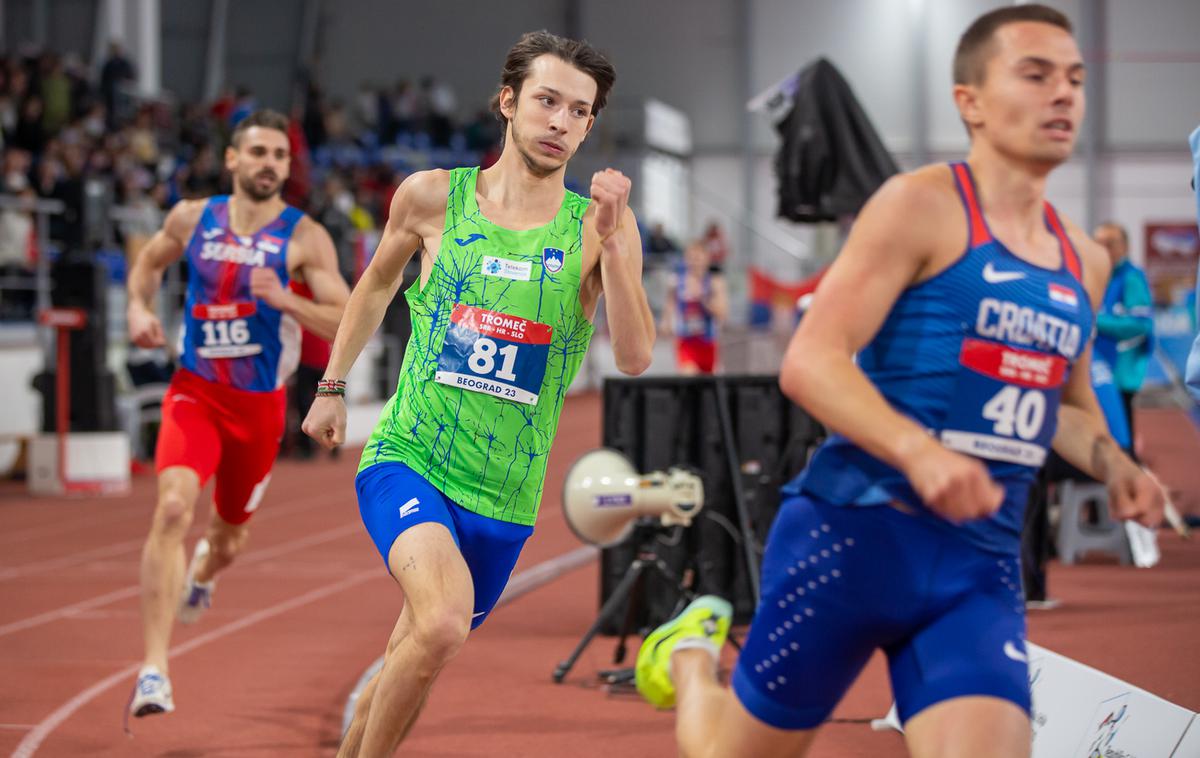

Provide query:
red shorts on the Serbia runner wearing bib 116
left=155, top=368, right=287, bottom=524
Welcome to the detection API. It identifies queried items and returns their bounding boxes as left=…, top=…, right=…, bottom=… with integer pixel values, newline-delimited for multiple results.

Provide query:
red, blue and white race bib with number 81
left=433, top=303, right=553, bottom=405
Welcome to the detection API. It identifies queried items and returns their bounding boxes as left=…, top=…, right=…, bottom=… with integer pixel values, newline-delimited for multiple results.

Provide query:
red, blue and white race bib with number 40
left=941, top=339, right=1067, bottom=467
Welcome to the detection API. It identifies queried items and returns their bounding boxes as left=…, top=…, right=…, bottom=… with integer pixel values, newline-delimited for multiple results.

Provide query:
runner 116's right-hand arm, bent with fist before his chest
left=250, top=216, right=350, bottom=339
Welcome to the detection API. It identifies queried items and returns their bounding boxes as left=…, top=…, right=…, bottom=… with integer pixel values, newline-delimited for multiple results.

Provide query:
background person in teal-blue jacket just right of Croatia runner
left=1092, top=221, right=1154, bottom=450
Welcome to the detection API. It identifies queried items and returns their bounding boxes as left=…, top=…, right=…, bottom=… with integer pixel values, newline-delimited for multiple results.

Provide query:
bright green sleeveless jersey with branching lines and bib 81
left=359, top=168, right=592, bottom=525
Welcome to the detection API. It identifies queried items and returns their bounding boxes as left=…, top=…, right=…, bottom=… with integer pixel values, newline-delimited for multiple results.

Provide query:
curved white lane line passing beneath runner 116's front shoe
left=12, top=569, right=379, bottom=758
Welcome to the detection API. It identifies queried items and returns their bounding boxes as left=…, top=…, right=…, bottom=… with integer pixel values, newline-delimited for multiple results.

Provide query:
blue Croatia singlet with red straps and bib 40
left=784, top=163, right=1093, bottom=553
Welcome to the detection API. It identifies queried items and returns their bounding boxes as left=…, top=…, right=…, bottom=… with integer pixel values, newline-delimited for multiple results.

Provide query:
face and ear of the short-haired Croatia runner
left=955, top=22, right=1084, bottom=166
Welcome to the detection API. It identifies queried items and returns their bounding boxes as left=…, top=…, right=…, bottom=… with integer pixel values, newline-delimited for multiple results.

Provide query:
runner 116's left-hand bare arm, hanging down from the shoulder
left=126, top=200, right=205, bottom=348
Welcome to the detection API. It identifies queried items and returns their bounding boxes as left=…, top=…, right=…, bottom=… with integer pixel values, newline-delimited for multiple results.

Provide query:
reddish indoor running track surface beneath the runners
left=0, top=396, right=1200, bottom=758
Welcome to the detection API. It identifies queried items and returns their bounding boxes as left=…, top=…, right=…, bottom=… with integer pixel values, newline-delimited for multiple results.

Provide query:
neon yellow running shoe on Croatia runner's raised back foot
left=634, top=595, right=733, bottom=708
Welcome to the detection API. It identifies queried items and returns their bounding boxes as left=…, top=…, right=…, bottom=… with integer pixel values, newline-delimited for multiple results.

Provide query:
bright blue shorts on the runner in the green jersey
left=354, top=462, right=533, bottom=628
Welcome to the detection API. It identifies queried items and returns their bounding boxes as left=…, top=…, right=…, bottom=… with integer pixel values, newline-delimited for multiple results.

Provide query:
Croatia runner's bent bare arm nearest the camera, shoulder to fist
left=780, top=167, right=1003, bottom=522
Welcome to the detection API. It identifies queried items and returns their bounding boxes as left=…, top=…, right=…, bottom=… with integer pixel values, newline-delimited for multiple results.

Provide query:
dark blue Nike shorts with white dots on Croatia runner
left=733, top=495, right=1030, bottom=729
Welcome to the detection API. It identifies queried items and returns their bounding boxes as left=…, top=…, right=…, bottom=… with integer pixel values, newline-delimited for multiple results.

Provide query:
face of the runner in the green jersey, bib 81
left=502, top=54, right=596, bottom=175
